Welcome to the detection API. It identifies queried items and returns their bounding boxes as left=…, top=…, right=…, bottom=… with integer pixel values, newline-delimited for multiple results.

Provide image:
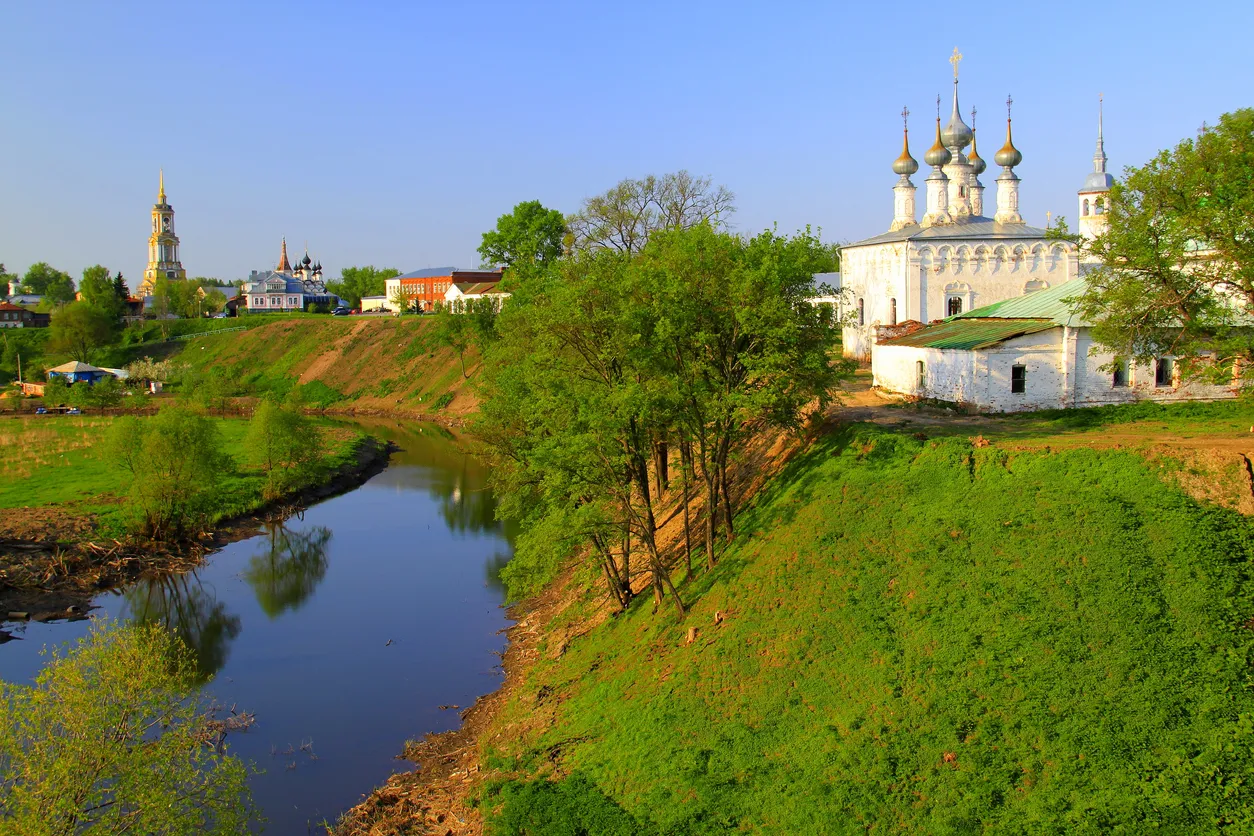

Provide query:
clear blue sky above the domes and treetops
left=0, top=0, right=1254, bottom=286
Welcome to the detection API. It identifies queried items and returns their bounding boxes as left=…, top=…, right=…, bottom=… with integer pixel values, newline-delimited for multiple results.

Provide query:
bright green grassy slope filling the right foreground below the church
left=483, top=428, right=1254, bottom=835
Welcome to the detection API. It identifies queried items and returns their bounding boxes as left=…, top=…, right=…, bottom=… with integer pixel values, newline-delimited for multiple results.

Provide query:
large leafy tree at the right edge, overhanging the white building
left=1081, top=108, right=1254, bottom=382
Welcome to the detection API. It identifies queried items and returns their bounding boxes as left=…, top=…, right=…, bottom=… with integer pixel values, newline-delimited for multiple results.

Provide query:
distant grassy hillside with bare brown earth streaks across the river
left=166, top=316, right=474, bottom=417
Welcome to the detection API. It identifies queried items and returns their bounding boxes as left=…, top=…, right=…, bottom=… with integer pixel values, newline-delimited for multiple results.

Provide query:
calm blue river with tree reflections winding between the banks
left=0, top=422, right=510, bottom=833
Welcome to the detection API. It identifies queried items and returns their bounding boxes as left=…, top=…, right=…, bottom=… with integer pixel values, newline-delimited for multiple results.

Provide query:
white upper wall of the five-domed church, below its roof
left=840, top=238, right=1080, bottom=360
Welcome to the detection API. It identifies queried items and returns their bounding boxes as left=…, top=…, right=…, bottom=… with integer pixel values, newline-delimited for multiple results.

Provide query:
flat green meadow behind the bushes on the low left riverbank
left=0, top=416, right=362, bottom=536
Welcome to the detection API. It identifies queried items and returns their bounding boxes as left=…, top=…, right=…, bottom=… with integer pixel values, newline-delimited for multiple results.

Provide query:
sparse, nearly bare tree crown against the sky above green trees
left=567, top=170, right=736, bottom=254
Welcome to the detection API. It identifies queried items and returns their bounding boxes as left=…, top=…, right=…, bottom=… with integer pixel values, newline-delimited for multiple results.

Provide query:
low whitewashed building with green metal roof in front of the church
left=872, top=278, right=1238, bottom=412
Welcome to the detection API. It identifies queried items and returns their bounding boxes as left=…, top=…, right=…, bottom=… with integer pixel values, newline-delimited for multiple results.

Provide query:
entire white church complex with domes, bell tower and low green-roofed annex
left=840, top=50, right=1236, bottom=412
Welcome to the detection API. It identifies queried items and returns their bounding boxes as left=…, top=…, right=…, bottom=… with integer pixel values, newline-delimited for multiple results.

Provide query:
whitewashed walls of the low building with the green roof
left=872, top=326, right=1236, bottom=412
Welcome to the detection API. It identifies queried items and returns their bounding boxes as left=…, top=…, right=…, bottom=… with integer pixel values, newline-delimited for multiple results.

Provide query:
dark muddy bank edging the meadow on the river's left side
left=0, top=419, right=391, bottom=623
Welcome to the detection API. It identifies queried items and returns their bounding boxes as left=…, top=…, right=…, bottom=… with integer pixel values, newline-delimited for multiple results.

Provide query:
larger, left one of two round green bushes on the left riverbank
left=105, top=406, right=233, bottom=541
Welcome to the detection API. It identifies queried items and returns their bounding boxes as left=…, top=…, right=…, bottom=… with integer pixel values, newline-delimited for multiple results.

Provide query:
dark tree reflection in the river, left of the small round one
left=124, top=572, right=240, bottom=683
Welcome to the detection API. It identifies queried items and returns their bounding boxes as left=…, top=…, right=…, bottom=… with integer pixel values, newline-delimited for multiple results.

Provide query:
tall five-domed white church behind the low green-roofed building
left=840, top=50, right=1110, bottom=361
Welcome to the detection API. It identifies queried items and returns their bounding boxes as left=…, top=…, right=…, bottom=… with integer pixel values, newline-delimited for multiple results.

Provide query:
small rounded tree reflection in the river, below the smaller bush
left=243, top=523, right=331, bottom=618
